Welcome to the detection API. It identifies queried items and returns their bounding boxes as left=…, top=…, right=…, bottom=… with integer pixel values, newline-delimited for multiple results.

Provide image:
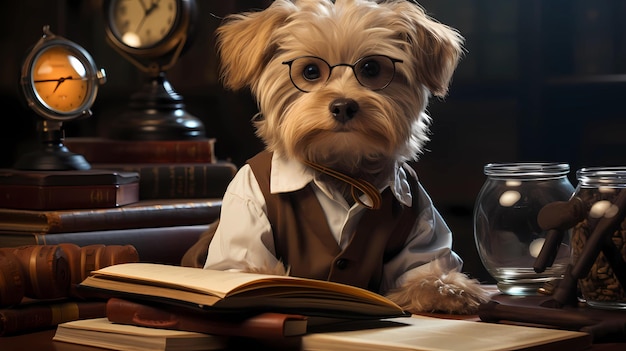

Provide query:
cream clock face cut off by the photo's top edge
left=109, top=0, right=179, bottom=49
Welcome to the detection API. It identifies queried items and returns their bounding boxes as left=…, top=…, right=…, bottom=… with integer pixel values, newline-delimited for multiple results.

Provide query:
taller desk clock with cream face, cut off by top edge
left=103, top=0, right=204, bottom=140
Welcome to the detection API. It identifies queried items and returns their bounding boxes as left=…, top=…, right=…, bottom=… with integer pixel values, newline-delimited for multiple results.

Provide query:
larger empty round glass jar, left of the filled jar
left=474, top=162, right=574, bottom=295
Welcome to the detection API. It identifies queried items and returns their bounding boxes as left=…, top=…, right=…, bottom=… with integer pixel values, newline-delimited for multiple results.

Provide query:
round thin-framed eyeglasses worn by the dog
left=283, top=55, right=402, bottom=93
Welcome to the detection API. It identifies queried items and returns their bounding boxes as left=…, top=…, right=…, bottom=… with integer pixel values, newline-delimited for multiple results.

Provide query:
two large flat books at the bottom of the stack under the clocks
left=0, top=198, right=222, bottom=264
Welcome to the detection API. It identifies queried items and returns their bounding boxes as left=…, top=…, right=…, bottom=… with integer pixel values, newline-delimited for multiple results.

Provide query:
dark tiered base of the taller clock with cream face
left=105, top=73, right=205, bottom=140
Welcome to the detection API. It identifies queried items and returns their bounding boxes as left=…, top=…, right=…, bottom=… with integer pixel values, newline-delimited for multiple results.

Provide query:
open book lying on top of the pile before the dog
left=80, top=263, right=407, bottom=318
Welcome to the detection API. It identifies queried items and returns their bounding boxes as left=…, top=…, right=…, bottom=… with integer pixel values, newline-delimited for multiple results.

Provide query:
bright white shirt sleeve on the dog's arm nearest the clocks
left=204, top=164, right=278, bottom=270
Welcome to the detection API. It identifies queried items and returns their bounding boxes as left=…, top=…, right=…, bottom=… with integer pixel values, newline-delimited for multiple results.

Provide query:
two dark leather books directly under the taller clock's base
left=65, top=137, right=237, bottom=200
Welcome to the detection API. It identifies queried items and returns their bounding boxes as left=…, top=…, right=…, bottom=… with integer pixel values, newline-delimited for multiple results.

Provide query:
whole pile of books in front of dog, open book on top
left=53, top=263, right=592, bottom=351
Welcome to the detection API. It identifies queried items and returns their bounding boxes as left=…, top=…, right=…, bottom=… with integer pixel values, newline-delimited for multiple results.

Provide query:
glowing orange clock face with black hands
left=32, top=46, right=89, bottom=113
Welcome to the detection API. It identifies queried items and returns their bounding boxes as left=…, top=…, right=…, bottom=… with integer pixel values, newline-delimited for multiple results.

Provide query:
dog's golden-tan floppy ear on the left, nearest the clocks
left=216, top=1, right=294, bottom=90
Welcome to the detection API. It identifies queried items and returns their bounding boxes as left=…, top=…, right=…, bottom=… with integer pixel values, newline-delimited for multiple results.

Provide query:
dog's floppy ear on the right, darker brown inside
left=395, top=1, right=464, bottom=97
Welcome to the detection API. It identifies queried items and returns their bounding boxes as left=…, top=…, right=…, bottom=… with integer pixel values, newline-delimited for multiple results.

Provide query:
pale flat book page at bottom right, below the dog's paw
left=302, top=316, right=591, bottom=351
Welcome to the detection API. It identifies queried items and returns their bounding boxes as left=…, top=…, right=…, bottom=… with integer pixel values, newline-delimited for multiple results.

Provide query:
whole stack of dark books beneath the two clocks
left=0, top=137, right=232, bottom=264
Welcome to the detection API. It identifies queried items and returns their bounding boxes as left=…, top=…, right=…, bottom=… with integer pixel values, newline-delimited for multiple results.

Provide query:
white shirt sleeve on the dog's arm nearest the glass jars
left=381, top=184, right=463, bottom=293
